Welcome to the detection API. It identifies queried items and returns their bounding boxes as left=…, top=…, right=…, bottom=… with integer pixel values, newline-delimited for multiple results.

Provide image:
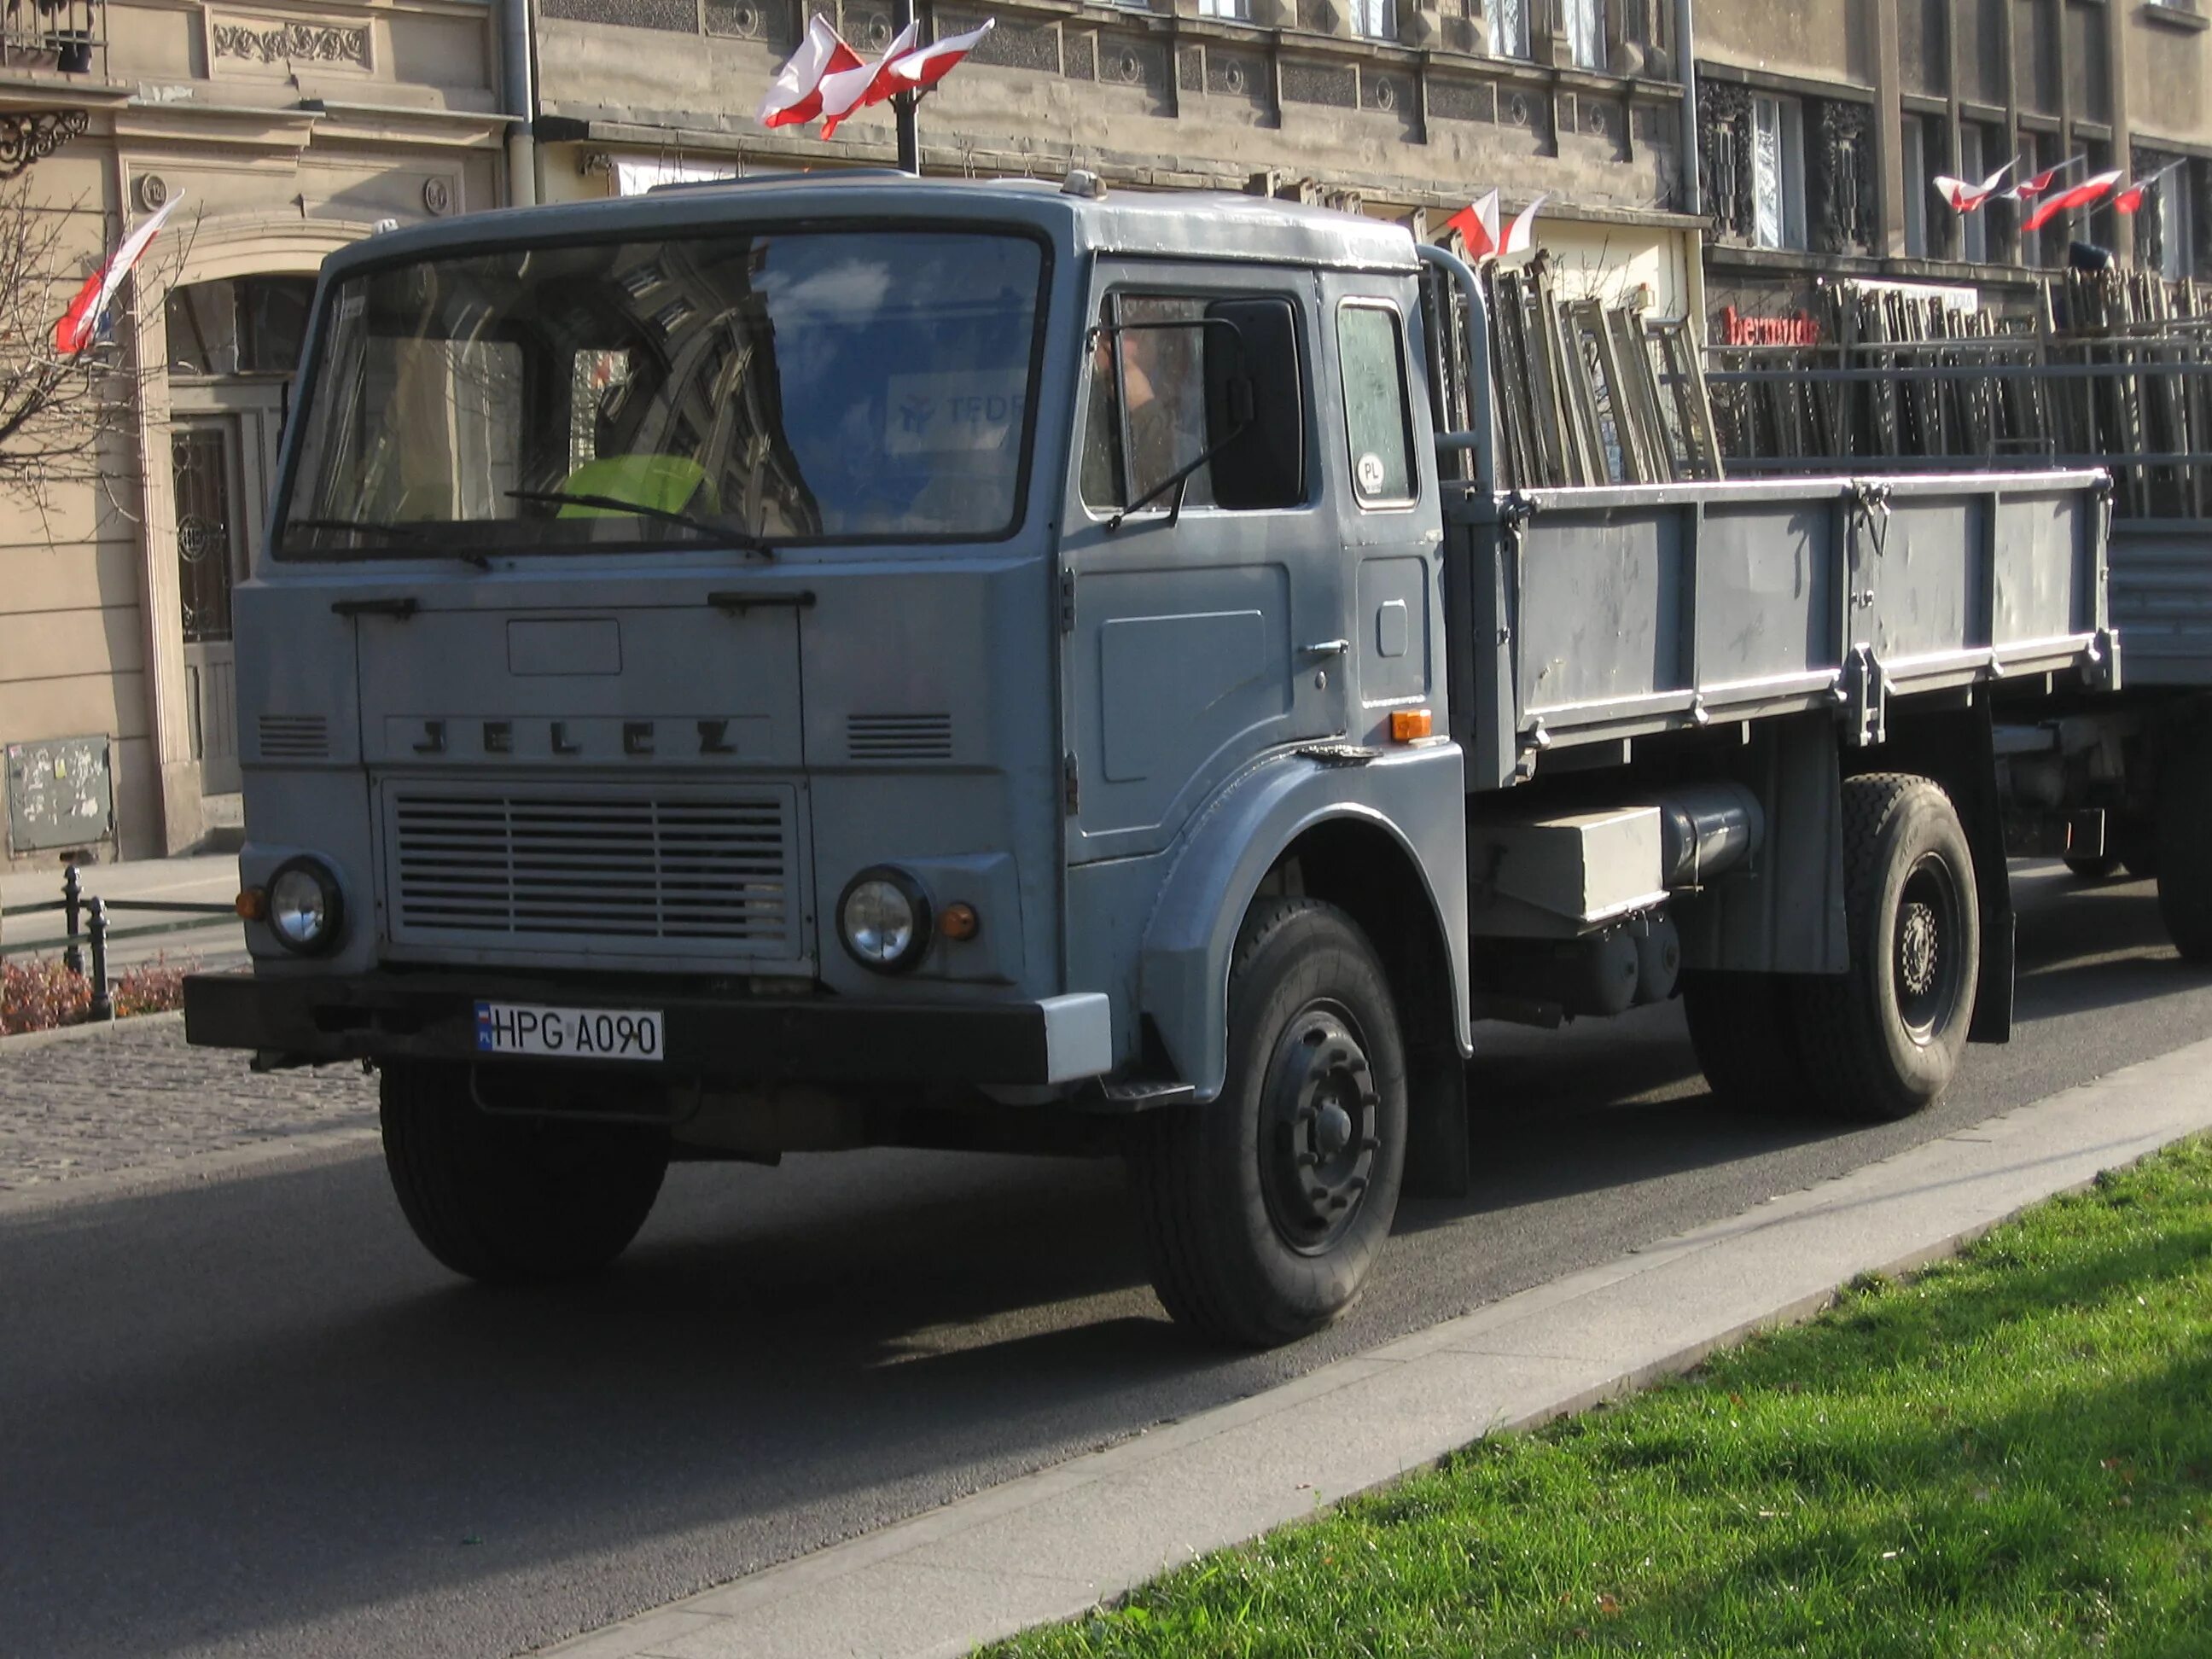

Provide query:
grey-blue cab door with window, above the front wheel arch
left=1062, top=263, right=1352, bottom=863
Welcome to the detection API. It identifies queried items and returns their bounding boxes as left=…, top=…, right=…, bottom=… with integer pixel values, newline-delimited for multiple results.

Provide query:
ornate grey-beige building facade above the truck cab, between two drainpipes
left=535, top=0, right=1697, bottom=311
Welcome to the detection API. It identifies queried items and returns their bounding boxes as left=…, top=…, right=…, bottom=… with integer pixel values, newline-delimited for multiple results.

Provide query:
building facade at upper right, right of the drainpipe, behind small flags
left=1694, top=0, right=2212, bottom=343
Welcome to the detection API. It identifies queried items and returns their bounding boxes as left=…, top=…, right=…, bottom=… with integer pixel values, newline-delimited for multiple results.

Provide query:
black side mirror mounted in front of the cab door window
left=1201, top=296, right=1305, bottom=511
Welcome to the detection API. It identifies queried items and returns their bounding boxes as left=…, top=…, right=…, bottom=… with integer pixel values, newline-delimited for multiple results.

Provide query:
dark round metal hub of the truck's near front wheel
left=1260, top=1002, right=1382, bottom=1254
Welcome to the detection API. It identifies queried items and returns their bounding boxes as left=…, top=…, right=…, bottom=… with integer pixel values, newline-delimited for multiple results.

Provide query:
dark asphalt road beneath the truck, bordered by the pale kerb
left=0, top=871, right=2212, bottom=1659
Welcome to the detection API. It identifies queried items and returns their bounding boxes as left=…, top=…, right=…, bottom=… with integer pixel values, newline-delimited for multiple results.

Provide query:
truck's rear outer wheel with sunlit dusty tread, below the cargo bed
left=1796, top=772, right=1982, bottom=1121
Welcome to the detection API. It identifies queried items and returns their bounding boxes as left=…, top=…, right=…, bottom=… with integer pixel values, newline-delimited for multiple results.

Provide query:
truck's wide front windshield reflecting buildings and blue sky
left=276, top=230, right=1044, bottom=557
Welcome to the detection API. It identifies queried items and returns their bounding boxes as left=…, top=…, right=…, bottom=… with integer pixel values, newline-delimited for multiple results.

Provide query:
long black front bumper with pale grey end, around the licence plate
left=183, top=973, right=1113, bottom=1084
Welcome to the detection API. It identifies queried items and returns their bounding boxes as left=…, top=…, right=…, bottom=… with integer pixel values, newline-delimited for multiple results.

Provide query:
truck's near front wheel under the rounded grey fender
left=1131, top=898, right=1407, bottom=1348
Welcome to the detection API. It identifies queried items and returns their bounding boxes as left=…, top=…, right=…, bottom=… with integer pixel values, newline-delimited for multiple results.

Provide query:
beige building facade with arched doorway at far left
left=0, top=0, right=511, bottom=864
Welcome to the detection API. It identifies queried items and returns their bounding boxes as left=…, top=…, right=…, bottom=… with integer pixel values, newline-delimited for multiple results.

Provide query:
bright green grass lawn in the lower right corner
left=991, top=1141, right=2212, bottom=1659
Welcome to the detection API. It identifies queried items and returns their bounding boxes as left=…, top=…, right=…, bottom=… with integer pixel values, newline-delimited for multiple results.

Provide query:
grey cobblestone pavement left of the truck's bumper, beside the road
left=0, top=1020, right=376, bottom=1192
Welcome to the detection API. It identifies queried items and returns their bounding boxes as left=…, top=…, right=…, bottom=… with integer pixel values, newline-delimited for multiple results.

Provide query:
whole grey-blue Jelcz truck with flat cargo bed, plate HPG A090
left=186, top=175, right=2117, bottom=1342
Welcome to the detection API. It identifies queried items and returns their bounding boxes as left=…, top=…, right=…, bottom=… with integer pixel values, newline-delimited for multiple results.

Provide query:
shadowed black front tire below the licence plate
left=381, top=1064, right=668, bottom=1285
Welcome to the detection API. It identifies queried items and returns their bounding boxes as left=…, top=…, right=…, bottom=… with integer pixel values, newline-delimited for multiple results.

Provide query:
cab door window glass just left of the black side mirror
left=1081, top=294, right=1214, bottom=511
